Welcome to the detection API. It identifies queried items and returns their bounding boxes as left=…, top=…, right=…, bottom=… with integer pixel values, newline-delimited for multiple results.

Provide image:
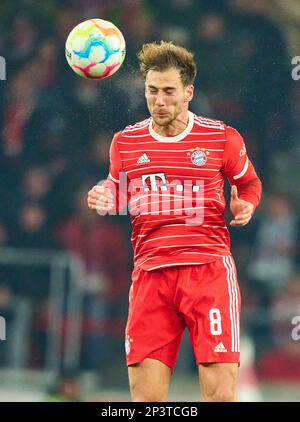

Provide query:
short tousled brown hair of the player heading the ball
left=137, top=41, right=197, bottom=86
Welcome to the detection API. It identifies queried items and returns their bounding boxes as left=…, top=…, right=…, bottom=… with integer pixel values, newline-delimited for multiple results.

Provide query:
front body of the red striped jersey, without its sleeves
left=117, top=113, right=229, bottom=270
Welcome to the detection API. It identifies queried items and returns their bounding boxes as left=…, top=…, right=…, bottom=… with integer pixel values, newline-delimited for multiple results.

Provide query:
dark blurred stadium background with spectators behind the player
left=0, top=0, right=300, bottom=401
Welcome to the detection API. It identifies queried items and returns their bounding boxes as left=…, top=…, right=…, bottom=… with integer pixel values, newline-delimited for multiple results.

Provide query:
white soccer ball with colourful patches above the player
left=66, top=19, right=126, bottom=79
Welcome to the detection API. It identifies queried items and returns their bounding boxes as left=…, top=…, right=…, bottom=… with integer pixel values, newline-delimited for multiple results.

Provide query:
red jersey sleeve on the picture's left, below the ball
left=102, top=132, right=128, bottom=214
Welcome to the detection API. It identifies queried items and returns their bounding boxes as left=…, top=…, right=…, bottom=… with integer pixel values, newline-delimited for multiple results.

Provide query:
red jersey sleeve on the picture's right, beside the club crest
left=222, top=126, right=262, bottom=210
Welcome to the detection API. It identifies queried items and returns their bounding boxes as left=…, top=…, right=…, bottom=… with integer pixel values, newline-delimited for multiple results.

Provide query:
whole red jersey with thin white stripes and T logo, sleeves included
left=104, top=111, right=261, bottom=271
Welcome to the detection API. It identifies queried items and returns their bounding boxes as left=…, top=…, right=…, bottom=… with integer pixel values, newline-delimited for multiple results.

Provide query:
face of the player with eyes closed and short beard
left=145, top=68, right=194, bottom=126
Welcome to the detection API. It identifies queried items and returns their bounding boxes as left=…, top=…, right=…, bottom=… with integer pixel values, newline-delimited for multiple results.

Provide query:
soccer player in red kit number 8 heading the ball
left=87, top=41, right=261, bottom=402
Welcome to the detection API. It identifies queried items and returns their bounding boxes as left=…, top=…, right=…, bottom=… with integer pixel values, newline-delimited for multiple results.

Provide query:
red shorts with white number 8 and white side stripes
left=125, top=256, right=240, bottom=372
